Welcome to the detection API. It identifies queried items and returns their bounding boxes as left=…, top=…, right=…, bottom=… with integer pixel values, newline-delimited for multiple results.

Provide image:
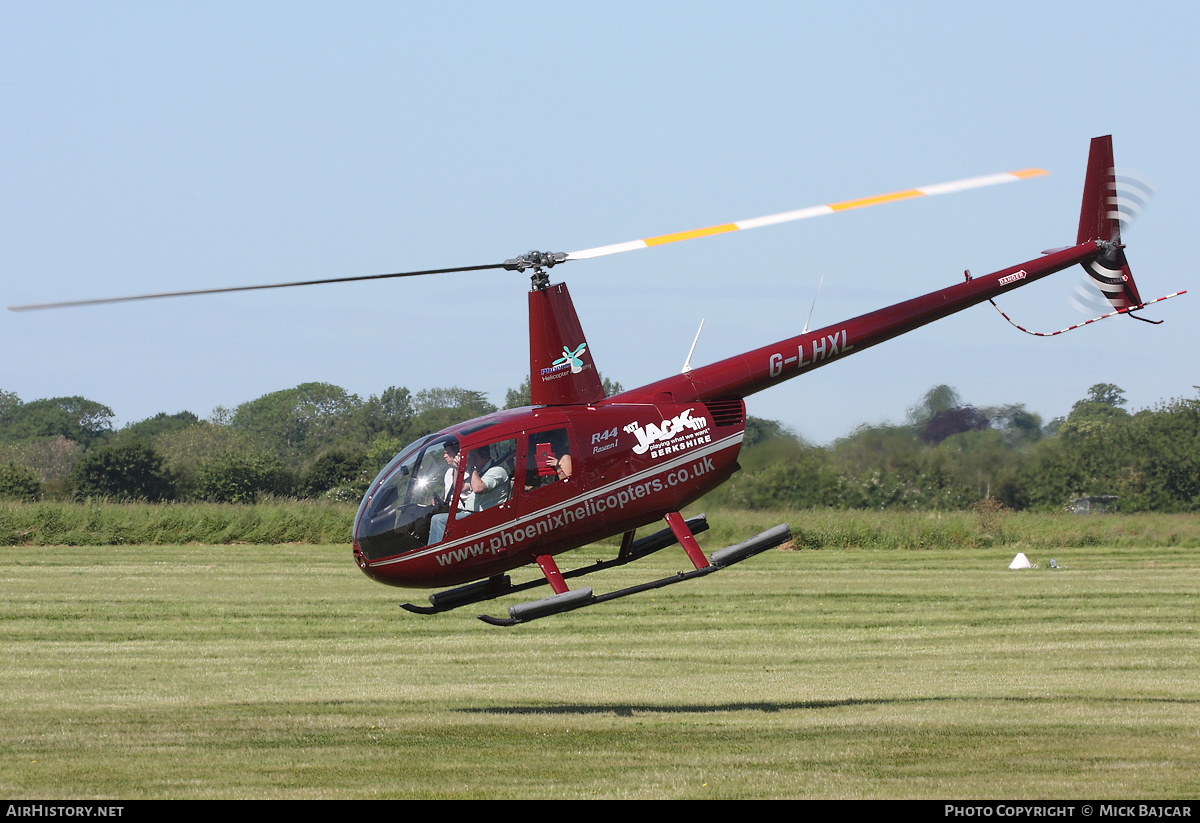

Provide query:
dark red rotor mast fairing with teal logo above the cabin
left=529, top=283, right=605, bottom=406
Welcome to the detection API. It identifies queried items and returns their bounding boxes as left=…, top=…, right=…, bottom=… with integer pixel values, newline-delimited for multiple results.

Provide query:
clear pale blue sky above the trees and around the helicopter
left=0, top=0, right=1200, bottom=444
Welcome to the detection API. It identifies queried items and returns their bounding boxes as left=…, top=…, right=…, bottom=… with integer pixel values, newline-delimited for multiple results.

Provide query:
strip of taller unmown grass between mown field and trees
left=9, top=500, right=1200, bottom=551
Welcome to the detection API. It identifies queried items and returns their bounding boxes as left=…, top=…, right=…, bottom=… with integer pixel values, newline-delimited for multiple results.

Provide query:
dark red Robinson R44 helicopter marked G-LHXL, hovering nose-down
left=10, top=136, right=1184, bottom=626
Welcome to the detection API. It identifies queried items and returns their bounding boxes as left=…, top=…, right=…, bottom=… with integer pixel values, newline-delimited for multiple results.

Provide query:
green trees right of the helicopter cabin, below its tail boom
left=714, top=383, right=1200, bottom=512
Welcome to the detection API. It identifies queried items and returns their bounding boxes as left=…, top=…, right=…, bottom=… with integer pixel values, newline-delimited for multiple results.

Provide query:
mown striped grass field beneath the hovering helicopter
left=0, top=515, right=1200, bottom=799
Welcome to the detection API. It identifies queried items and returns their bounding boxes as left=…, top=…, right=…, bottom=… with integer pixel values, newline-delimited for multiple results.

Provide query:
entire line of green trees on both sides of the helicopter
left=0, top=380, right=1200, bottom=511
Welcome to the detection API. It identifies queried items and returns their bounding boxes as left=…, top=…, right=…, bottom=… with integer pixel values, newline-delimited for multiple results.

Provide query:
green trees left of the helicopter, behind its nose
left=0, top=378, right=620, bottom=503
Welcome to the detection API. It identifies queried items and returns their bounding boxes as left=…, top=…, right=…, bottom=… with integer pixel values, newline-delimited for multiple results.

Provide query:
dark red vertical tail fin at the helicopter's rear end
left=1075, top=134, right=1142, bottom=308
